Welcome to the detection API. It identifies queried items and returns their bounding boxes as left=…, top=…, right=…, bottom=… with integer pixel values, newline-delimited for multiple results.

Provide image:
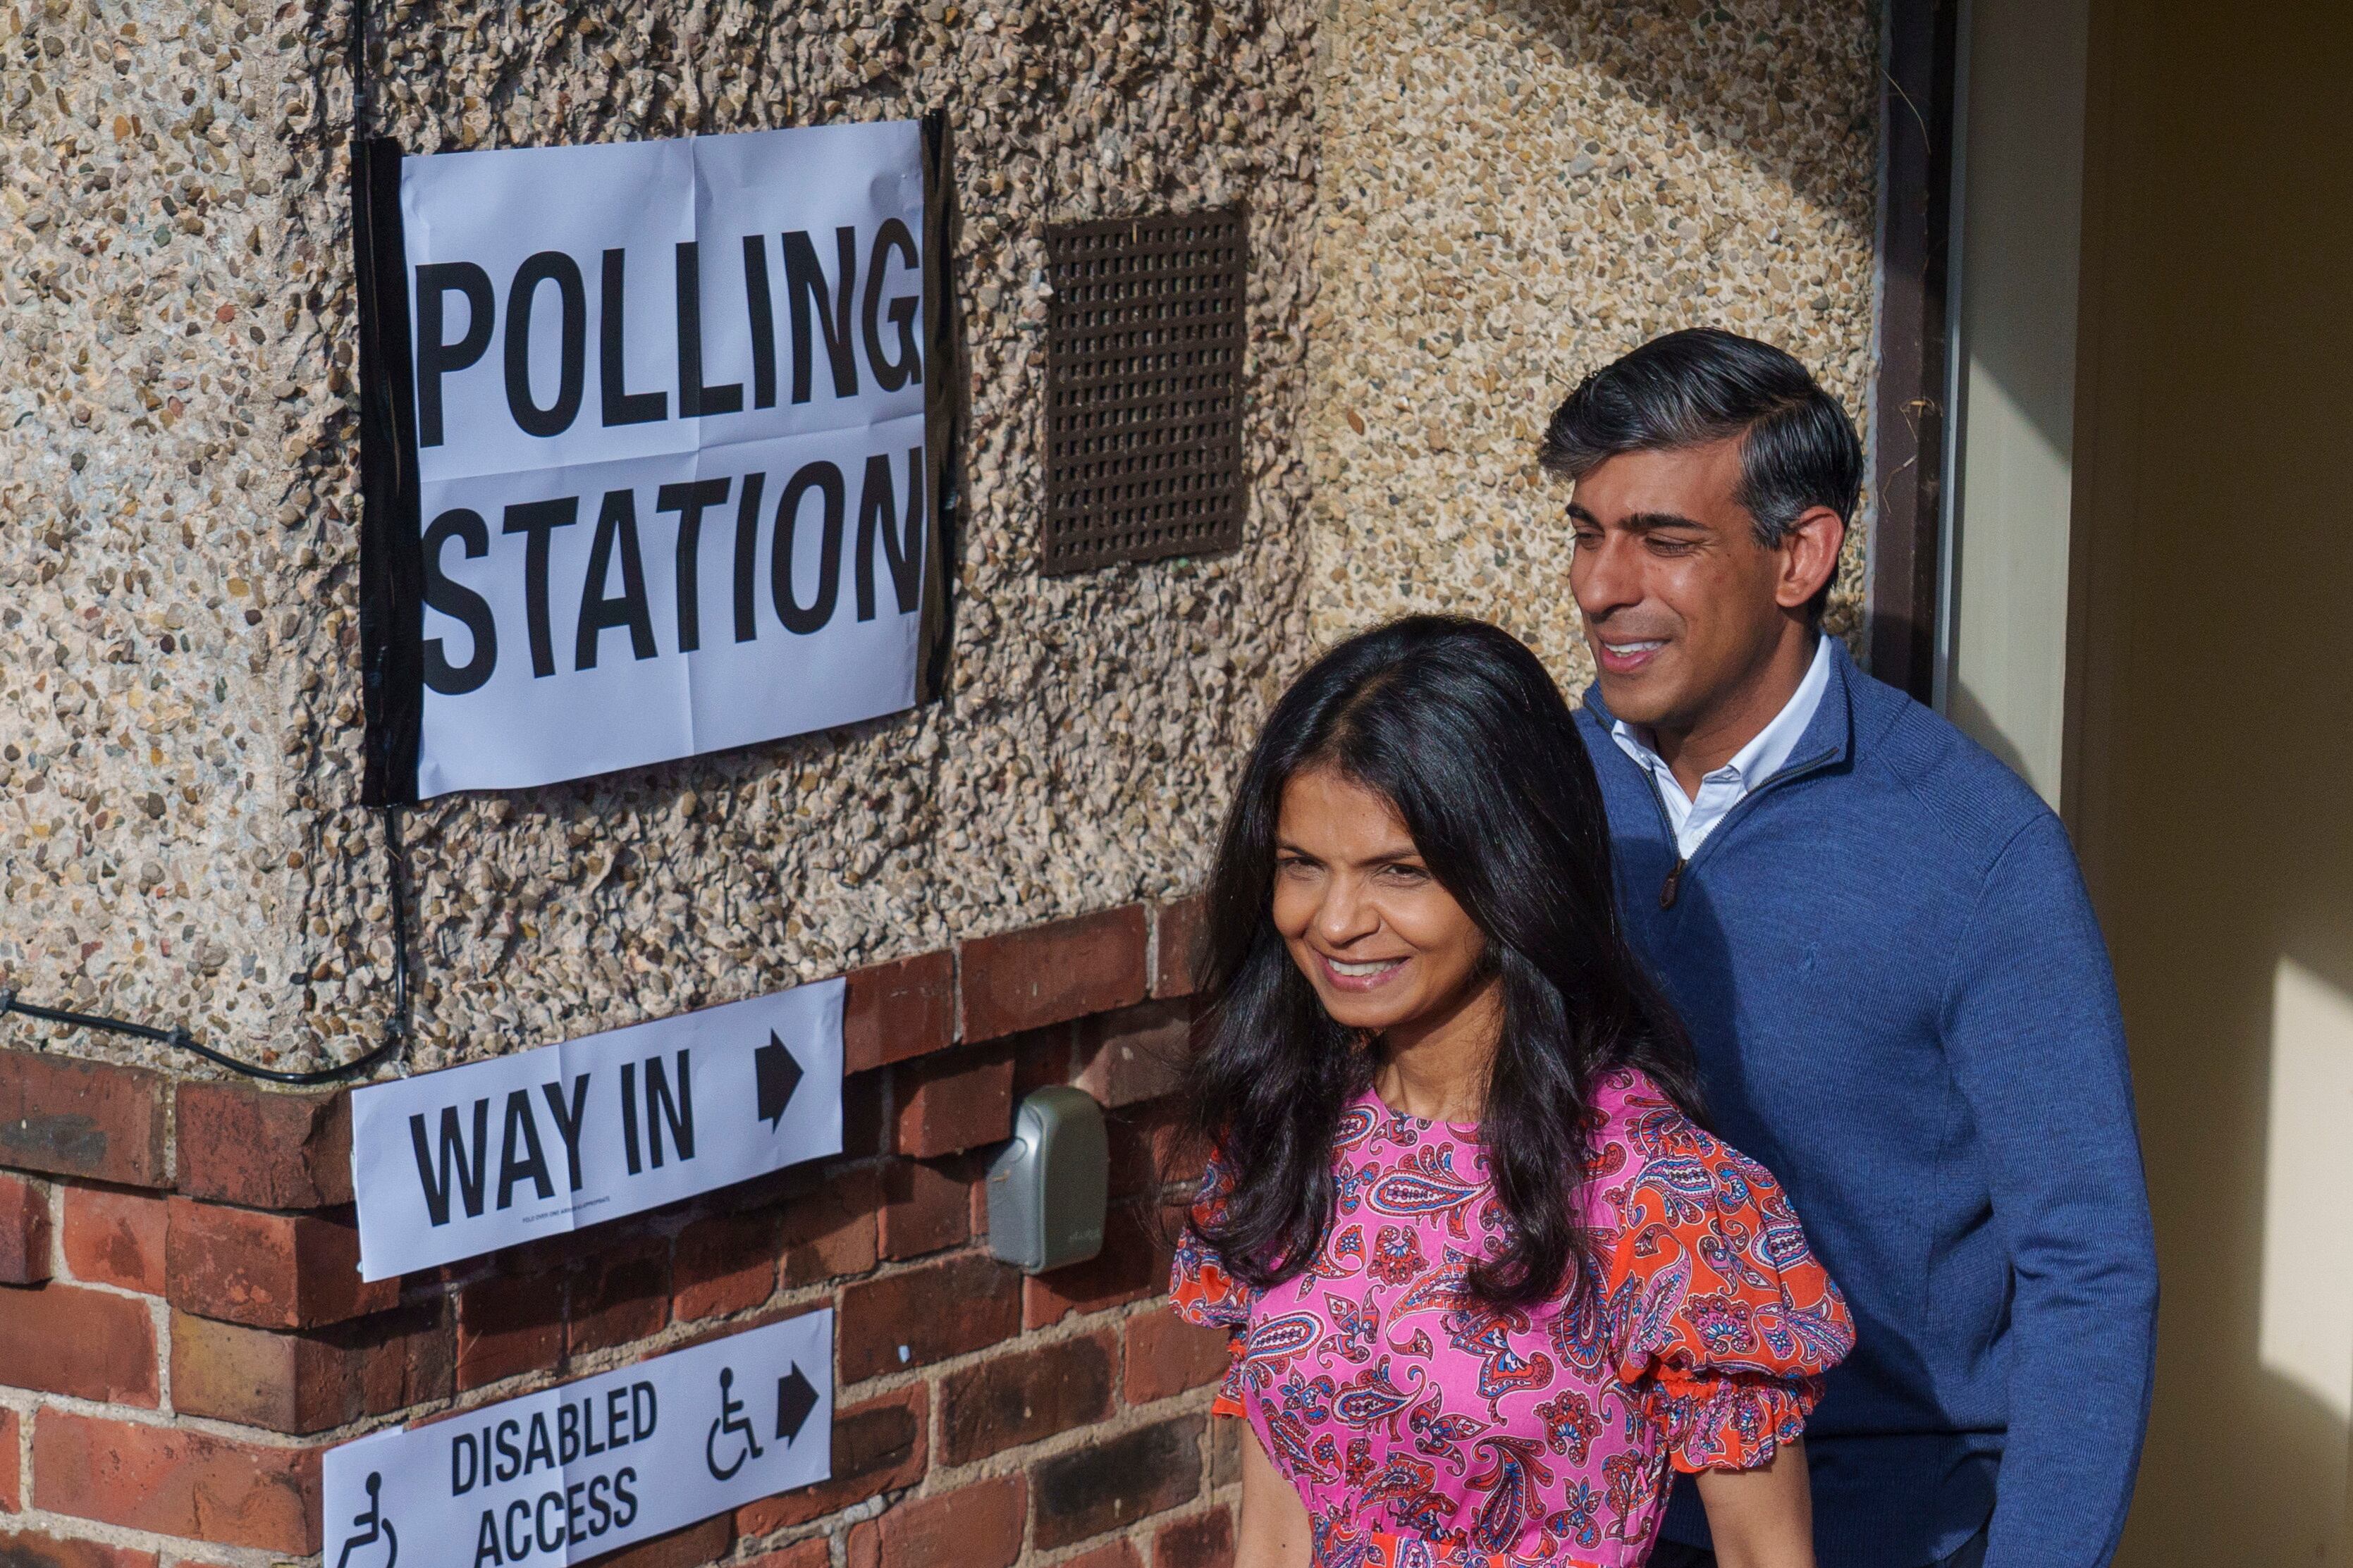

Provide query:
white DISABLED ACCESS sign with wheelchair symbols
left=322, top=1309, right=833, bottom=1568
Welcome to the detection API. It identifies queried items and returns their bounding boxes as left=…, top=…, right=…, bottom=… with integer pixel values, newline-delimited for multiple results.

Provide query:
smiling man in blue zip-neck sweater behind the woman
left=1544, top=331, right=2158, bottom=1568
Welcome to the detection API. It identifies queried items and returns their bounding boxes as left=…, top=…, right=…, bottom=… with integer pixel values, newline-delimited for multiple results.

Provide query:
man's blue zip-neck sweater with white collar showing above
left=1579, top=649, right=2158, bottom=1568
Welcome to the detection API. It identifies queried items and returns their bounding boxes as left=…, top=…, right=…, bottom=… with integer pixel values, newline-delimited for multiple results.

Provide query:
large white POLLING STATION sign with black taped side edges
left=353, top=120, right=953, bottom=804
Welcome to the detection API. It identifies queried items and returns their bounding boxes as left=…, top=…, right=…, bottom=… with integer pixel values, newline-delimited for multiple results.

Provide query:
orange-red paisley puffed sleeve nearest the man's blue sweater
left=1609, top=1117, right=1854, bottom=1471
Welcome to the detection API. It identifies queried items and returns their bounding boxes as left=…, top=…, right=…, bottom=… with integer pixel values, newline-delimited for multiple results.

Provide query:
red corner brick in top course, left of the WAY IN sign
left=174, top=1081, right=350, bottom=1209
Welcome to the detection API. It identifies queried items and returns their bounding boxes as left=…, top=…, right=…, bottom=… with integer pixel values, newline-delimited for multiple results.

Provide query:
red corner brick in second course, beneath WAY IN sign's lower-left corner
left=165, top=1197, right=400, bottom=1328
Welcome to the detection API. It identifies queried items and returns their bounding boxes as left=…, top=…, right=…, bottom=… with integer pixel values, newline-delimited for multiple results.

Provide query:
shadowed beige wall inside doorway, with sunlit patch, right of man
left=2066, top=0, right=2353, bottom=1568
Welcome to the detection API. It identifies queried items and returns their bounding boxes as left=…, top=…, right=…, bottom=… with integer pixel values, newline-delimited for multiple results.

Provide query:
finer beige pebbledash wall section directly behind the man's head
left=1310, top=0, right=1878, bottom=689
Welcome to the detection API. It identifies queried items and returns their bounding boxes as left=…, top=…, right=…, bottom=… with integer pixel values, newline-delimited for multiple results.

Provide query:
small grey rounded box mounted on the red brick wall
left=988, top=1086, right=1111, bottom=1274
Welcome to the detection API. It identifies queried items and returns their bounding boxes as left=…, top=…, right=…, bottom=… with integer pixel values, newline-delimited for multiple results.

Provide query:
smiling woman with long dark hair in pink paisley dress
left=1172, top=616, right=1854, bottom=1568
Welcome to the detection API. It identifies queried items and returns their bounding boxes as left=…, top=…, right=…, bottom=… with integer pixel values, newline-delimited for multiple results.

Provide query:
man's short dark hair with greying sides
left=1539, top=327, right=1864, bottom=618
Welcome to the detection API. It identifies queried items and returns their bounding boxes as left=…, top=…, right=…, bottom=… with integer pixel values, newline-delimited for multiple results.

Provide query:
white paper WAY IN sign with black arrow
left=350, top=980, right=844, bottom=1279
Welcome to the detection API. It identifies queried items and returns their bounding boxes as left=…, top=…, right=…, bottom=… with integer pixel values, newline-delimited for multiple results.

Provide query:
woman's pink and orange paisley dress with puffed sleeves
left=1172, top=1072, right=1854, bottom=1568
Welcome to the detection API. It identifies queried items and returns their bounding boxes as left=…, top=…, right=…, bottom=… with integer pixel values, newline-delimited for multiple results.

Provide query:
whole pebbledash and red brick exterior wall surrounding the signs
left=0, top=0, right=1875, bottom=1568
